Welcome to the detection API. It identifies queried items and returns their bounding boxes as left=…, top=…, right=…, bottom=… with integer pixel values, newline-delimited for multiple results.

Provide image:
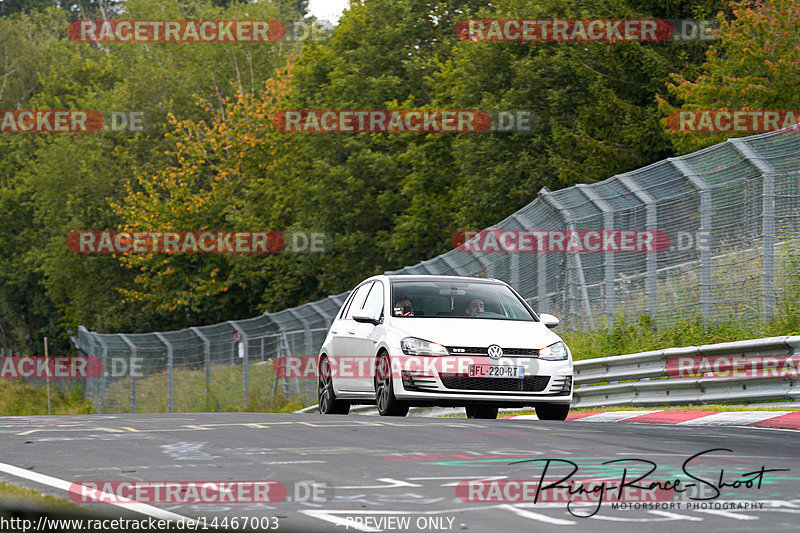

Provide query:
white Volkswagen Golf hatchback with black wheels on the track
left=317, top=276, right=573, bottom=420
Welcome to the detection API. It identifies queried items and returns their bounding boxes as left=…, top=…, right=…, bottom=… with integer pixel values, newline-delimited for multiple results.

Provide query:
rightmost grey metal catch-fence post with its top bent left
left=727, top=139, right=775, bottom=320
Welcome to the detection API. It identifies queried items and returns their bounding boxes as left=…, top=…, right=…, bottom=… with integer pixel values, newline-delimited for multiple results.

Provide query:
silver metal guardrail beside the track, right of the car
left=572, top=336, right=800, bottom=408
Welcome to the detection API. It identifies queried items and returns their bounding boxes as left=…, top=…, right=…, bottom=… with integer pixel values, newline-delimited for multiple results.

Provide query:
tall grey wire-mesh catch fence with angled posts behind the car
left=75, top=127, right=800, bottom=412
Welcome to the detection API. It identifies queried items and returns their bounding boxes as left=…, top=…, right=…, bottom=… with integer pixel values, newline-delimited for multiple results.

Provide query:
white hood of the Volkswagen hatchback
left=392, top=317, right=561, bottom=350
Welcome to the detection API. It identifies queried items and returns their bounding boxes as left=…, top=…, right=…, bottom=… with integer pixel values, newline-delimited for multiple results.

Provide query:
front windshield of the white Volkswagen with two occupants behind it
left=392, top=281, right=536, bottom=322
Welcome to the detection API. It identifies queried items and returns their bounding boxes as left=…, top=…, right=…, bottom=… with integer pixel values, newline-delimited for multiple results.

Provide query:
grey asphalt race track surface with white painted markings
left=0, top=413, right=800, bottom=533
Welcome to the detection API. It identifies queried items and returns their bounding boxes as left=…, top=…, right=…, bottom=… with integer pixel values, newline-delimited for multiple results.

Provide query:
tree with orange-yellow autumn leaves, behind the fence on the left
left=112, top=68, right=291, bottom=319
